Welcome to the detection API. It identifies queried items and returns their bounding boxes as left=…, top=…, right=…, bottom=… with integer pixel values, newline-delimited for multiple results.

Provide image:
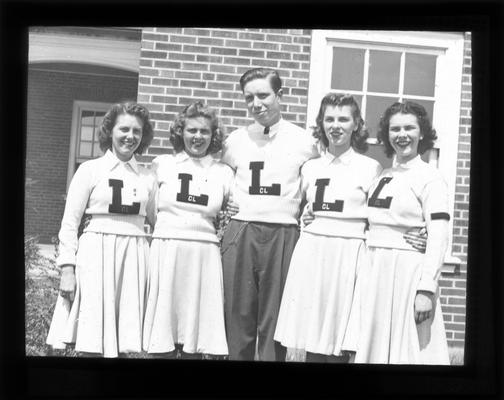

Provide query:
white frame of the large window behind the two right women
left=307, top=30, right=464, bottom=265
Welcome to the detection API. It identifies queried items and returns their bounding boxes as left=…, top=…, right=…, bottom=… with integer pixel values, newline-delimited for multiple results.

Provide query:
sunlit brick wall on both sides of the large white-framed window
left=138, top=28, right=471, bottom=345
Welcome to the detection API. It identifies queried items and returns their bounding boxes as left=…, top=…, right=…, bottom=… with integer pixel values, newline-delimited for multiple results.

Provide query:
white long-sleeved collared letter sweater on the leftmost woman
left=56, top=150, right=157, bottom=266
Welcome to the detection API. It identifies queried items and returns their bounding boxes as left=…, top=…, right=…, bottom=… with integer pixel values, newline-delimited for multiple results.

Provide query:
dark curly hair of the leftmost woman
left=98, top=102, right=154, bottom=154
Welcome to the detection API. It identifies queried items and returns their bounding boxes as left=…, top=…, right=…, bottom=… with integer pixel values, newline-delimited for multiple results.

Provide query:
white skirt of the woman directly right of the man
left=275, top=232, right=366, bottom=356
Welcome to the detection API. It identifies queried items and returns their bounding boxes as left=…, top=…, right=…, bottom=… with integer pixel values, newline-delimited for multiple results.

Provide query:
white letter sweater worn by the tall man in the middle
left=222, top=119, right=318, bottom=224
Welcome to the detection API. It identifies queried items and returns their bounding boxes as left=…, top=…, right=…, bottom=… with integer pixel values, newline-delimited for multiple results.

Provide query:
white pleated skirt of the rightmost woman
left=345, top=248, right=450, bottom=365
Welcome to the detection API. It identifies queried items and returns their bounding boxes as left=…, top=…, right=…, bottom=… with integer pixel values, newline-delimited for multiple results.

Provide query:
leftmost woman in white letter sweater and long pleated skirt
left=47, top=103, right=157, bottom=357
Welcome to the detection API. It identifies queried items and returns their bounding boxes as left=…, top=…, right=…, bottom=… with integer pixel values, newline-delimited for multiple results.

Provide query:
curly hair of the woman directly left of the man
left=170, top=101, right=224, bottom=154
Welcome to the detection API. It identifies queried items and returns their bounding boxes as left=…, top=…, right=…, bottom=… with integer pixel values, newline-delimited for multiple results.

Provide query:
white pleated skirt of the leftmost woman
left=47, top=232, right=149, bottom=357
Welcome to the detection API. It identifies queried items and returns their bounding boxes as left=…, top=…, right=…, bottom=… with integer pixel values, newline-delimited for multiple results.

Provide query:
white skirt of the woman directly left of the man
left=143, top=238, right=228, bottom=355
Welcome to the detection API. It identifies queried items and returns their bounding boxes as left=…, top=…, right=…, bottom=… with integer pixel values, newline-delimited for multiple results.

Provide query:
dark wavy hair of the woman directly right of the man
left=312, top=93, right=369, bottom=153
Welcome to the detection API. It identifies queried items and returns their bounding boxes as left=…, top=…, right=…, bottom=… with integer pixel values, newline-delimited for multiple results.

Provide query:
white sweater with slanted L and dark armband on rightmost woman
left=367, top=156, right=450, bottom=292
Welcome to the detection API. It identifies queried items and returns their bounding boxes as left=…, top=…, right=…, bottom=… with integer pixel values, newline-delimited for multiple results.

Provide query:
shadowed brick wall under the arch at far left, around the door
left=25, top=66, right=138, bottom=244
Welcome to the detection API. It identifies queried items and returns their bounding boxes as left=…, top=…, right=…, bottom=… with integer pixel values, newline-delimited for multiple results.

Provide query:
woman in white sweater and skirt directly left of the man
left=143, top=102, right=234, bottom=358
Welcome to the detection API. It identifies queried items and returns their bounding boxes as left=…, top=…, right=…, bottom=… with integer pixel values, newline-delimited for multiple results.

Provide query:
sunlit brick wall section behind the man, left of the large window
left=138, top=28, right=311, bottom=163
